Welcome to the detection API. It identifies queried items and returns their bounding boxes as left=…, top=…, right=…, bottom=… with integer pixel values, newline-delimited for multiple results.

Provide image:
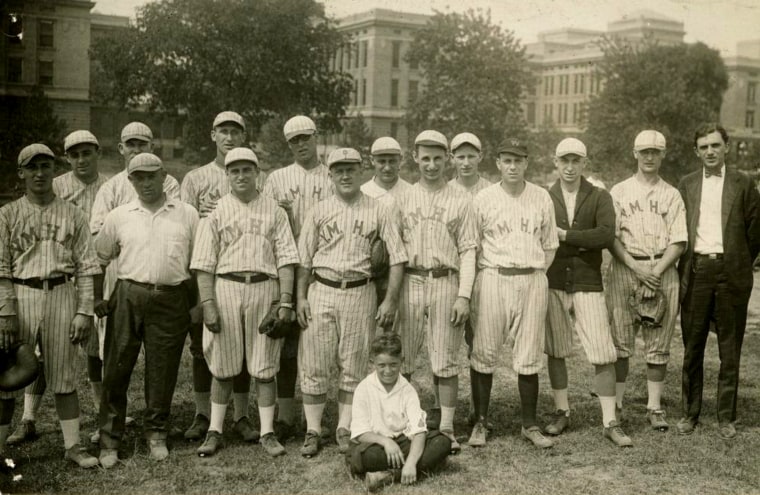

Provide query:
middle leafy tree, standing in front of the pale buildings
left=406, top=9, right=532, bottom=159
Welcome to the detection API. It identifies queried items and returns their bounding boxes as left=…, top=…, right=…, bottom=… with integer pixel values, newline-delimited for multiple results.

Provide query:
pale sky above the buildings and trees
left=93, top=0, right=760, bottom=56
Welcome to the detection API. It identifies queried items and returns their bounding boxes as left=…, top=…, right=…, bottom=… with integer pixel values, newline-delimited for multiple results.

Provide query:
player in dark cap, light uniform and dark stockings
left=470, top=139, right=559, bottom=448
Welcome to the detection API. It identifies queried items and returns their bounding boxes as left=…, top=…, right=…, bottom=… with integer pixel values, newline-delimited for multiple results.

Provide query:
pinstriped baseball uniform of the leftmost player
left=0, top=196, right=100, bottom=398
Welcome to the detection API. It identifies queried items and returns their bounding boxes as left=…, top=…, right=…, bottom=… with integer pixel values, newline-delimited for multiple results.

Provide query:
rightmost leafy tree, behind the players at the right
left=585, top=40, right=728, bottom=184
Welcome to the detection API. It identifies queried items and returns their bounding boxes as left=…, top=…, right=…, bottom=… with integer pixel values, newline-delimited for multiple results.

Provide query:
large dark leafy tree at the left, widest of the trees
left=92, top=0, right=351, bottom=161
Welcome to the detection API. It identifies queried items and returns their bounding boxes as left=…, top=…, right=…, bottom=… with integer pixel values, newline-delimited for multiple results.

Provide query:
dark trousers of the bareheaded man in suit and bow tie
left=681, top=256, right=747, bottom=423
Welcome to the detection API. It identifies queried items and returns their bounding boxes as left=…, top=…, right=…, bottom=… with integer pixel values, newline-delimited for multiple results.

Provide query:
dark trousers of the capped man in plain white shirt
left=99, top=280, right=190, bottom=449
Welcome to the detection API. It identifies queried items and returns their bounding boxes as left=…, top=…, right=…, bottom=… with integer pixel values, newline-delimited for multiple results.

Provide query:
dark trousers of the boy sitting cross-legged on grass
left=346, top=430, right=451, bottom=474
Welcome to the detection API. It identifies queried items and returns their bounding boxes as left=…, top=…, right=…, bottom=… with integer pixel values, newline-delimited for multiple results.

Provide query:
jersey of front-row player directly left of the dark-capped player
left=396, top=183, right=478, bottom=270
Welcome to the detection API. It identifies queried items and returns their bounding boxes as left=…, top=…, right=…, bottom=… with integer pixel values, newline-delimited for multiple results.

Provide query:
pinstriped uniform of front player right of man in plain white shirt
left=190, top=194, right=298, bottom=380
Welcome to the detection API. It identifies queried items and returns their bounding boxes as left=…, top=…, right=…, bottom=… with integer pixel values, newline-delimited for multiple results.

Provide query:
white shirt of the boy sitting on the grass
left=351, top=371, right=427, bottom=439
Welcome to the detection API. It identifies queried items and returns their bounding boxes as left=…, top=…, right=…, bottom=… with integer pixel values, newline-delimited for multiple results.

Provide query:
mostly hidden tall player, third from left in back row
left=180, top=111, right=258, bottom=442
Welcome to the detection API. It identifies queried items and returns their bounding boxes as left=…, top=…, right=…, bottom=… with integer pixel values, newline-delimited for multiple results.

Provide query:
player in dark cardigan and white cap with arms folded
left=544, top=138, right=633, bottom=447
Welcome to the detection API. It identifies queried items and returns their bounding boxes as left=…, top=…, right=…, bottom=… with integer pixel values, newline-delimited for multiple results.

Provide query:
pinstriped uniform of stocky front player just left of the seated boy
left=298, top=193, right=407, bottom=395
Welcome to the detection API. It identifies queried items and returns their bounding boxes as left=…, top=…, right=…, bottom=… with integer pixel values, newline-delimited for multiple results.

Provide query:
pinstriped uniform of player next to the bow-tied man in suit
left=606, top=176, right=688, bottom=364
